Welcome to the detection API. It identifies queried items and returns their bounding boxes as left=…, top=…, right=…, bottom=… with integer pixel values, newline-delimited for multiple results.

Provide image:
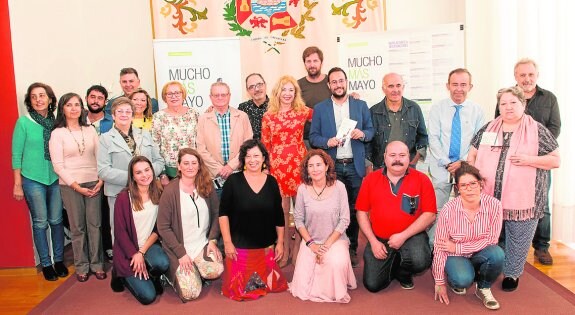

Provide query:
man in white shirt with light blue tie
left=427, top=68, right=485, bottom=248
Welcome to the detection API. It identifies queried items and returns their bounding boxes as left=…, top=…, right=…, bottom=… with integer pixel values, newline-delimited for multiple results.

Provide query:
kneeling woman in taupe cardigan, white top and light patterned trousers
left=157, top=148, right=224, bottom=302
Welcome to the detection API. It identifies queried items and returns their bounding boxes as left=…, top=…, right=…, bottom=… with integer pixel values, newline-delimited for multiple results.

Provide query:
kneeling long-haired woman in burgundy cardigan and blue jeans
left=111, top=156, right=169, bottom=305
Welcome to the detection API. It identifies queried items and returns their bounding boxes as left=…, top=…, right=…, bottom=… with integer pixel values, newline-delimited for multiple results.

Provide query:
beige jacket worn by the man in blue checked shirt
left=196, top=107, right=254, bottom=177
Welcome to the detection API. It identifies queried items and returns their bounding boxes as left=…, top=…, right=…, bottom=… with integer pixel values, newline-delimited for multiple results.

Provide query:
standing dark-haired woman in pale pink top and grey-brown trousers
left=49, top=93, right=106, bottom=282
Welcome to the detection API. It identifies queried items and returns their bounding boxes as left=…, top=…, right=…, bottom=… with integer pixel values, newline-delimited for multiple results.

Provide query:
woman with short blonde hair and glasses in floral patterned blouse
left=152, top=81, right=199, bottom=186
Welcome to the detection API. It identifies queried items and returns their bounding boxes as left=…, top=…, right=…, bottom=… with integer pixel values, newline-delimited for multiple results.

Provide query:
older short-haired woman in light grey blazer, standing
left=97, top=96, right=164, bottom=256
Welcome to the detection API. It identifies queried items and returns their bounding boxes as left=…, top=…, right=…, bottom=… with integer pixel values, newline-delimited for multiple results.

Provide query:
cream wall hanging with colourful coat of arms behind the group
left=151, top=0, right=383, bottom=97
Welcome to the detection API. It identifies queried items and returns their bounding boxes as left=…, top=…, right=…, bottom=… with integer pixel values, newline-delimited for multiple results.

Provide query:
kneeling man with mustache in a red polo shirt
left=355, top=141, right=437, bottom=292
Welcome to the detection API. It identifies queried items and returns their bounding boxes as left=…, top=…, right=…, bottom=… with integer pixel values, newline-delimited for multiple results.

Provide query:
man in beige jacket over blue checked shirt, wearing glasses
left=196, top=82, right=254, bottom=196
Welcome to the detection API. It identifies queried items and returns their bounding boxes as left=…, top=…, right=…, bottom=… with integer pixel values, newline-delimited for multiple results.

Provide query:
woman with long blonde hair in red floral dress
left=262, top=76, right=312, bottom=267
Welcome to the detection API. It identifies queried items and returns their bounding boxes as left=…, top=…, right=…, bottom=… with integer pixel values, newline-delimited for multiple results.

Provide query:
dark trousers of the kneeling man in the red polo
left=363, top=231, right=431, bottom=292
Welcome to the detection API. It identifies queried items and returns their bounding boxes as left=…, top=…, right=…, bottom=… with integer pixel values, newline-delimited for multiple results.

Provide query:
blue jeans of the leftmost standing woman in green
left=22, top=176, right=64, bottom=267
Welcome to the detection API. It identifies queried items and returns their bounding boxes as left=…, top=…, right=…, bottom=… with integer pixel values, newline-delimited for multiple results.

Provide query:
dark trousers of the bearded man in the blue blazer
left=335, top=163, right=362, bottom=251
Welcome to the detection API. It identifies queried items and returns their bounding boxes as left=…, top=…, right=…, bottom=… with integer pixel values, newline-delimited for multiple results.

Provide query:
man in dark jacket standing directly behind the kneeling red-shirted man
left=368, top=72, right=428, bottom=169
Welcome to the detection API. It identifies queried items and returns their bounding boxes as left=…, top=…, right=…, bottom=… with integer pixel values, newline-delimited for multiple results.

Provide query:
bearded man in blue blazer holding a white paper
left=310, top=67, right=374, bottom=267
